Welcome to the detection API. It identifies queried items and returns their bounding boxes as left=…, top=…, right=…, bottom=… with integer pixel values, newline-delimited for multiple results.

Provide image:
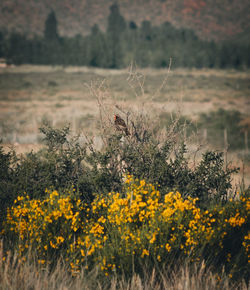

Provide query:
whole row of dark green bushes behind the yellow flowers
left=0, top=112, right=239, bottom=228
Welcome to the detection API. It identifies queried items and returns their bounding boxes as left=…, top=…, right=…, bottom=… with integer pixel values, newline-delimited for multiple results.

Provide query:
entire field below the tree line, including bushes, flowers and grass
left=0, top=66, right=250, bottom=290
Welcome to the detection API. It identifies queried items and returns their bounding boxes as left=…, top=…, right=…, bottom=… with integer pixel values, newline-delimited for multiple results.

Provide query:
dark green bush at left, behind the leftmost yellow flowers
left=0, top=126, right=85, bottom=227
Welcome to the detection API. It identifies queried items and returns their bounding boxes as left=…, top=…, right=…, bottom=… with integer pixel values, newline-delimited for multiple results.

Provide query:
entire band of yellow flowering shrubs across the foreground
left=2, top=175, right=250, bottom=275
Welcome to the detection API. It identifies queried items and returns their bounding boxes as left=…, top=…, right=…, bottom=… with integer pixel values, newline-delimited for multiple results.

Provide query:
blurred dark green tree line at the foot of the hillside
left=0, top=4, right=250, bottom=68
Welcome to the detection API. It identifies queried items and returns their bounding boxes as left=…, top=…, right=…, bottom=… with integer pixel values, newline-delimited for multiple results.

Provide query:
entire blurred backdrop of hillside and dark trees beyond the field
left=0, top=0, right=250, bottom=68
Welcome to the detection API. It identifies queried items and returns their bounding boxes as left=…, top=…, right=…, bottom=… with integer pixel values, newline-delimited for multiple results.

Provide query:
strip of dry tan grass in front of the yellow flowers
left=0, top=248, right=248, bottom=290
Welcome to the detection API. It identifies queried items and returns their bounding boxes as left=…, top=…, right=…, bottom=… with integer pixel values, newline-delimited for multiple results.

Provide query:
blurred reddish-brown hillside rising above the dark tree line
left=0, top=0, right=250, bottom=41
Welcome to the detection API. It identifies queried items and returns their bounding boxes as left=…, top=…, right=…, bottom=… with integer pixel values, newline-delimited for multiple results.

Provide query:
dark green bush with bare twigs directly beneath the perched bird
left=78, top=110, right=237, bottom=206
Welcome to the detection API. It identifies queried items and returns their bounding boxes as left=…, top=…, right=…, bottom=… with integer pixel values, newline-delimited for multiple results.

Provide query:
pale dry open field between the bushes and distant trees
left=0, top=65, right=250, bottom=186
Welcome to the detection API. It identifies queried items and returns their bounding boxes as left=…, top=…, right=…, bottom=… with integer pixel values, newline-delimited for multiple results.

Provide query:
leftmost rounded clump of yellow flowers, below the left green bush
left=5, top=191, right=84, bottom=264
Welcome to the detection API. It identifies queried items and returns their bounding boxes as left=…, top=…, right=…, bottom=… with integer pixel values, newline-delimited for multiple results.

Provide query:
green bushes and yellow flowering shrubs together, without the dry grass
left=0, top=107, right=250, bottom=287
